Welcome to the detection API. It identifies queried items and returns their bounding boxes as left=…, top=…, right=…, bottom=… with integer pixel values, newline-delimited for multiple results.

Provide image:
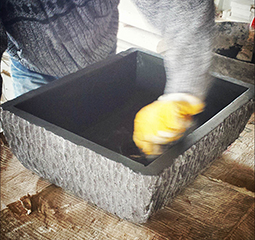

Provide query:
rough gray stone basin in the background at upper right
left=212, top=22, right=255, bottom=84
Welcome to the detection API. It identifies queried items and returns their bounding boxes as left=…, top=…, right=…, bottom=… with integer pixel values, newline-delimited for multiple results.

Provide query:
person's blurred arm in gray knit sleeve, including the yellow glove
left=133, top=0, right=214, bottom=155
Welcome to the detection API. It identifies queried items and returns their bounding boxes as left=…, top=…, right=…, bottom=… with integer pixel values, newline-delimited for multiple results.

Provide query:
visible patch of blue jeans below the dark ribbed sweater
left=11, top=59, right=57, bottom=97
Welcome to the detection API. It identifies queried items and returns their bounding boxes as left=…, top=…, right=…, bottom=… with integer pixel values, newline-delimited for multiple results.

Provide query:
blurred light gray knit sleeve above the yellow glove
left=133, top=0, right=214, bottom=99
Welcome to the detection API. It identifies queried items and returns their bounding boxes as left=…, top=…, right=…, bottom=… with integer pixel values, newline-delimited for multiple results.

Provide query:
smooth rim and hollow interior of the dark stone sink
left=3, top=49, right=253, bottom=173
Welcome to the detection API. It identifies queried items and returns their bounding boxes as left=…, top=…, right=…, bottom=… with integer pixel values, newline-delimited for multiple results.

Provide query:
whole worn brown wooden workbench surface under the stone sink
left=0, top=114, right=255, bottom=240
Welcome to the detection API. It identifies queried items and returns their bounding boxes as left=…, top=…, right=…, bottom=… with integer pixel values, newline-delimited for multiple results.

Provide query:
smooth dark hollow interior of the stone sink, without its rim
left=15, top=52, right=247, bottom=165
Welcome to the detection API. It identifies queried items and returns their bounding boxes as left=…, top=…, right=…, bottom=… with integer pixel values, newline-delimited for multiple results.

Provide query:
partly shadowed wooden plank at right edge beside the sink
left=204, top=118, right=255, bottom=192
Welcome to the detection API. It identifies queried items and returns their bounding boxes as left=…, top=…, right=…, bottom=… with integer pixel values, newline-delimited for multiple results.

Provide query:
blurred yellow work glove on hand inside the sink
left=133, top=93, right=205, bottom=156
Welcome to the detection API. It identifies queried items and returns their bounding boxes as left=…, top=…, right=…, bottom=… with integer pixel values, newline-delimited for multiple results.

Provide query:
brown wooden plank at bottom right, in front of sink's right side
left=145, top=175, right=254, bottom=239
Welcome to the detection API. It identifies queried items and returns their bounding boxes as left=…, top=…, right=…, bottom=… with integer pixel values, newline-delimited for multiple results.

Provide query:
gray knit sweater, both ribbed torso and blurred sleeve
left=0, top=0, right=214, bottom=98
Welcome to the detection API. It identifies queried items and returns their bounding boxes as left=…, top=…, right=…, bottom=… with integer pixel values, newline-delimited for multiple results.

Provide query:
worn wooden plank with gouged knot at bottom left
left=1, top=185, right=165, bottom=240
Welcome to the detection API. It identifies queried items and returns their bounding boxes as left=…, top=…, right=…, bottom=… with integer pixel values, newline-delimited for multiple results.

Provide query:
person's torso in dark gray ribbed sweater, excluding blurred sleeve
left=1, top=0, right=119, bottom=77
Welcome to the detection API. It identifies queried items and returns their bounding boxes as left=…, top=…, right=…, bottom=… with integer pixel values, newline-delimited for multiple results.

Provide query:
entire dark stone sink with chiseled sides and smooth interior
left=0, top=49, right=254, bottom=223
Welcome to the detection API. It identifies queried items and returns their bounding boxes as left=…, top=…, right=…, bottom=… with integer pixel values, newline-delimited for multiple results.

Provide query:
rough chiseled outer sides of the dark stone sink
left=1, top=101, right=253, bottom=223
